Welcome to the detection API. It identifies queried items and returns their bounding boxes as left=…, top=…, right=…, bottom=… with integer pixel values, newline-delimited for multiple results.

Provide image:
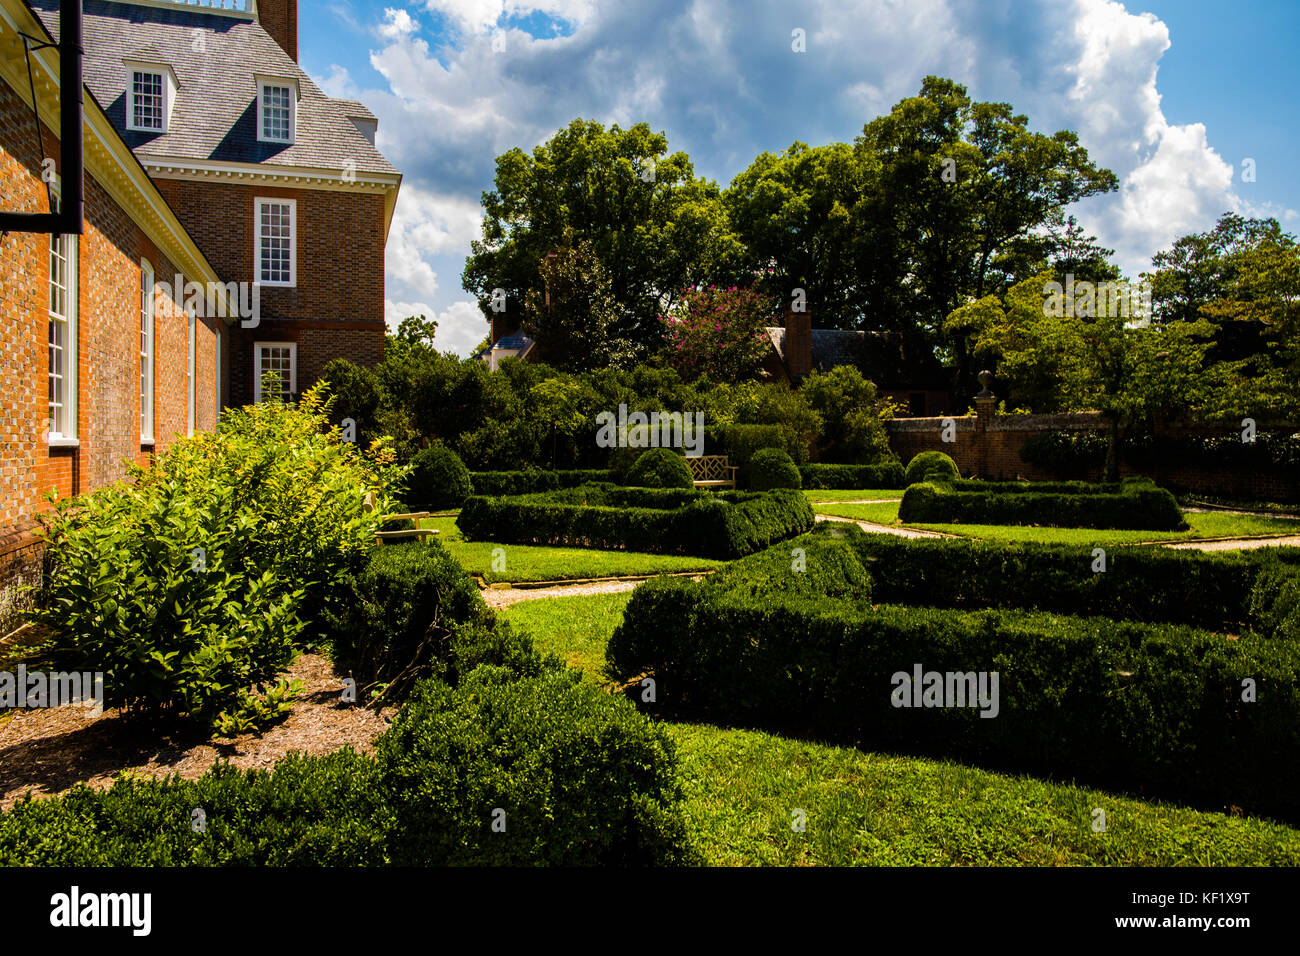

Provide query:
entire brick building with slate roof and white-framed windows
left=0, top=0, right=400, bottom=595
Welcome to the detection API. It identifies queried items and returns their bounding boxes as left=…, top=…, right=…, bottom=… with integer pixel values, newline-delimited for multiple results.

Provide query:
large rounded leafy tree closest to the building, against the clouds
left=462, top=120, right=742, bottom=347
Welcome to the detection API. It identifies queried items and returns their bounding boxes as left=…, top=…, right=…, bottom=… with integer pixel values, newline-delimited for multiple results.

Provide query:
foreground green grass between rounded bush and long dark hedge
left=503, top=593, right=1300, bottom=866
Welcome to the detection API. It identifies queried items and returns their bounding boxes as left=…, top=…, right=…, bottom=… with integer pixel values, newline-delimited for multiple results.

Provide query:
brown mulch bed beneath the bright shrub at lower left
left=0, top=654, right=390, bottom=809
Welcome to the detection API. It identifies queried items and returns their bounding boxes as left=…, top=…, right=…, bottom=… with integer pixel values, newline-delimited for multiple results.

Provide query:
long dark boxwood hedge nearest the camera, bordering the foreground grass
left=607, top=579, right=1300, bottom=818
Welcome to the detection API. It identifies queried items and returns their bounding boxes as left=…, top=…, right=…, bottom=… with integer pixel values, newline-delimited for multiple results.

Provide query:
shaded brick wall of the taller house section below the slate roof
left=157, top=179, right=385, bottom=405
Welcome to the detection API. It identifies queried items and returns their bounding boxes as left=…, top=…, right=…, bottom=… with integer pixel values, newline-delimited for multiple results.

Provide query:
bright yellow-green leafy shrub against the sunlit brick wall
left=33, top=389, right=402, bottom=727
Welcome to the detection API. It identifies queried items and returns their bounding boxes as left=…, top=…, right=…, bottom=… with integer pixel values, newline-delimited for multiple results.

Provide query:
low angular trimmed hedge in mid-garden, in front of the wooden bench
left=456, top=485, right=815, bottom=559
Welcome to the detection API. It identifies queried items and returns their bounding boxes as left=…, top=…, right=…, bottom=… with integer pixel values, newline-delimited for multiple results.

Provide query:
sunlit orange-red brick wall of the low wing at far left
left=0, top=83, right=216, bottom=556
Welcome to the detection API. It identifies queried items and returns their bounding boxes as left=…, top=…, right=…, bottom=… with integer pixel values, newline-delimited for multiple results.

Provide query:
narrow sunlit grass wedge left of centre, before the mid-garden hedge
left=421, top=518, right=724, bottom=583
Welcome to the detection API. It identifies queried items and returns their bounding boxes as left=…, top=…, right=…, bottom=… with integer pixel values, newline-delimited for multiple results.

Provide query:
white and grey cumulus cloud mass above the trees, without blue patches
left=326, top=0, right=1268, bottom=347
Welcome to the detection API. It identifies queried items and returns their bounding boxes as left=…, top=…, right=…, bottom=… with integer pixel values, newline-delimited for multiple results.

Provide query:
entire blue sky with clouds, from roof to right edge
left=299, top=0, right=1300, bottom=354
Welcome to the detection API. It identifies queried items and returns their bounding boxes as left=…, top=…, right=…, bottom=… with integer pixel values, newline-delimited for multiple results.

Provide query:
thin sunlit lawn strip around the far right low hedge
left=813, top=502, right=1300, bottom=545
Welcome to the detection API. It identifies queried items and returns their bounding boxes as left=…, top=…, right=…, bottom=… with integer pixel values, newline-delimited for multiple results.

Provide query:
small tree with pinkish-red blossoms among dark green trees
left=662, top=286, right=776, bottom=382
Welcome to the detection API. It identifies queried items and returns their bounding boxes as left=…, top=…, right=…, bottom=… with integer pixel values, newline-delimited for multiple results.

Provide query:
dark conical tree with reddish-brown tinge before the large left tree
left=524, top=229, right=632, bottom=371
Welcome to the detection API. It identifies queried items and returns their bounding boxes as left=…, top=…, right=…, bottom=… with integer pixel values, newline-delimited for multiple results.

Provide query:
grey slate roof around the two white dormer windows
left=27, top=0, right=398, bottom=174
